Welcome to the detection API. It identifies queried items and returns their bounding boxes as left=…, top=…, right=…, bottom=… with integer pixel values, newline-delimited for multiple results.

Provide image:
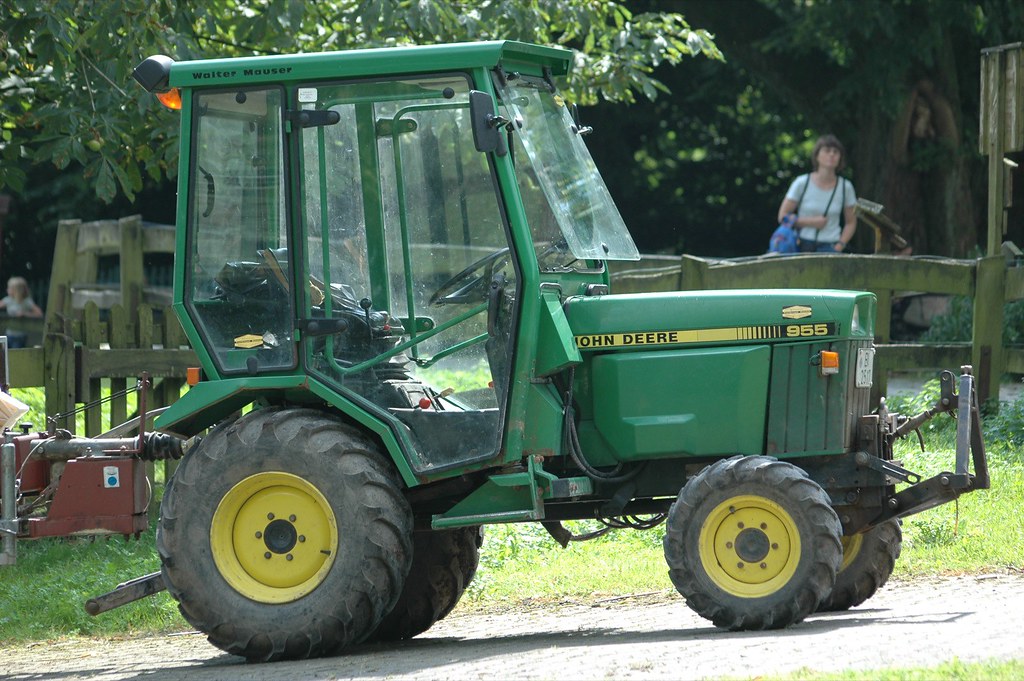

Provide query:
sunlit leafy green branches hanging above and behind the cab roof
left=0, top=0, right=721, bottom=202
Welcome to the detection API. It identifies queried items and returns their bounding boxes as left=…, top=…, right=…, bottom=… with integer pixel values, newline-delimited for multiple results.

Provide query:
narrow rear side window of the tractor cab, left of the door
left=185, top=88, right=296, bottom=374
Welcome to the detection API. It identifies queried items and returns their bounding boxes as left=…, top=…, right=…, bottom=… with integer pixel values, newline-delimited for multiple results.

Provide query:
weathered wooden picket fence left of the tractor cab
left=7, top=215, right=198, bottom=436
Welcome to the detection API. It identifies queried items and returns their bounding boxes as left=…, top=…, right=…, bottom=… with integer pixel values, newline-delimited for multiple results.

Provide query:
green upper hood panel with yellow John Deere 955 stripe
left=563, top=289, right=876, bottom=351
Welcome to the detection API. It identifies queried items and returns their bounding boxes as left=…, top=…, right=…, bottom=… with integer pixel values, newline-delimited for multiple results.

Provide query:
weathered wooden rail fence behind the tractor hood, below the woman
left=611, top=244, right=1024, bottom=399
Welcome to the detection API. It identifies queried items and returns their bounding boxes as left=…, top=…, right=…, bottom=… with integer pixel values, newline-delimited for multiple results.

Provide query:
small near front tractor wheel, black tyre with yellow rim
left=665, top=457, right=842, bottom=630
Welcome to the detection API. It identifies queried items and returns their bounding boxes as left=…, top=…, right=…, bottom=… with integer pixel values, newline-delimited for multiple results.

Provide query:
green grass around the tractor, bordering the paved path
left=0, top=382, right=1024, bottom=659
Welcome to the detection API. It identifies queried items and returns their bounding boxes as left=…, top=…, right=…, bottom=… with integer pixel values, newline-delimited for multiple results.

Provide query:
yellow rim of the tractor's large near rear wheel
left=210, top=472, right=338, bottom=603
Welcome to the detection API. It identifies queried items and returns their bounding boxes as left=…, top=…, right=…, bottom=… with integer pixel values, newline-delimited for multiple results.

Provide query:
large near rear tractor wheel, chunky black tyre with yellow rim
left=157, top=409, right=412, bottom=661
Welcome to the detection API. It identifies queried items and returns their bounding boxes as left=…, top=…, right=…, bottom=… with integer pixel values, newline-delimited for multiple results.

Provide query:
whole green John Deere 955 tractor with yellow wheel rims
left=125, top=42, right=988, bottom=661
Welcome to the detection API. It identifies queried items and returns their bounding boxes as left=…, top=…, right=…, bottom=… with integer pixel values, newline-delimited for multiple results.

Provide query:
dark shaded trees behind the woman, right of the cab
left=588, top=0, right=1024, bottom=257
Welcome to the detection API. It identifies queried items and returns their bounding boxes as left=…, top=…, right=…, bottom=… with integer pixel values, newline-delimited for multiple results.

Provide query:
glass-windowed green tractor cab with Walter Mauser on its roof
left=139, top=43, right=639, bottom=475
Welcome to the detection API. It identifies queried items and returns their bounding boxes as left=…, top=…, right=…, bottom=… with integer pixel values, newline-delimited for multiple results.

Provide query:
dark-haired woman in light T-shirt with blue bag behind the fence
left=778, top=135, right=857, bottom=253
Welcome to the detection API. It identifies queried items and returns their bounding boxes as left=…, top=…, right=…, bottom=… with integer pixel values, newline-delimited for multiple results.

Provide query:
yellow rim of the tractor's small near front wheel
left=699, top=496, right=800, bottom=598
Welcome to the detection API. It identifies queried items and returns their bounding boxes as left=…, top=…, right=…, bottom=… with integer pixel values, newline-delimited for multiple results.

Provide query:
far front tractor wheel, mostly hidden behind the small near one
left=818, top=520, right=903, bottom=610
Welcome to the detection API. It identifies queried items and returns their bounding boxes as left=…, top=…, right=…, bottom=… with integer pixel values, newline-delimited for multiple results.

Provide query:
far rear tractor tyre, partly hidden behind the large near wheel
left=370, top=527, right=483, bottom=641
